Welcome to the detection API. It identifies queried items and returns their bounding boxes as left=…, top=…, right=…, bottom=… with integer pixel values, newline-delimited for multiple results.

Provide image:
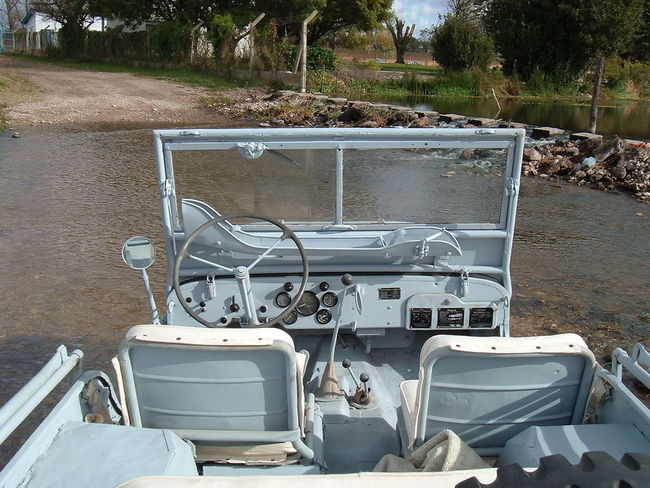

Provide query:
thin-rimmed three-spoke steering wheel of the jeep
left=173, top=214, right=309, bottom=327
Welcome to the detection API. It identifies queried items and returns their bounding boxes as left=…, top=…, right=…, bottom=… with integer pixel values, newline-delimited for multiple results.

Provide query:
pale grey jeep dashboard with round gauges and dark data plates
left=168, top=273, right=509, bottom=335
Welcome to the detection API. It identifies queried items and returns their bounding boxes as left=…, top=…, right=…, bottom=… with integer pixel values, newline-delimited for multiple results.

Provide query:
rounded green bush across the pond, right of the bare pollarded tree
left=431, top=15, right=494, bottom=70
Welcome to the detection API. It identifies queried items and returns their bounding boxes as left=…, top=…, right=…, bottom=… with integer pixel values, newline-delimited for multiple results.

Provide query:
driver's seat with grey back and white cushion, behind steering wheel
left=116, top=325, right=319, bottom=464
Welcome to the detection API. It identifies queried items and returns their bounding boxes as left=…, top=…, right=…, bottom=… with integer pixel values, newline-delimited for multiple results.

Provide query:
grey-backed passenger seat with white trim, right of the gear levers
left=400, top=334, right=596, bottom=455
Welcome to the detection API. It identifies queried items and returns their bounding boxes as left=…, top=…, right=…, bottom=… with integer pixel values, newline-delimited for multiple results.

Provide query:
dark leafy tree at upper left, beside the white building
left=31, top=0, right=92, bottom=57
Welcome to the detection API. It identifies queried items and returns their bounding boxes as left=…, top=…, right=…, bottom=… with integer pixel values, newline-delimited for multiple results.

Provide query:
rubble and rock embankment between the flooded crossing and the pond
left=211, top=90, right=650, bottom=202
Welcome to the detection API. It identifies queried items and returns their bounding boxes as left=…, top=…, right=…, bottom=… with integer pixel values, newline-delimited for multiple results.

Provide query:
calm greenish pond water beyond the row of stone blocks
left=370, top=97, right=650, bottom=140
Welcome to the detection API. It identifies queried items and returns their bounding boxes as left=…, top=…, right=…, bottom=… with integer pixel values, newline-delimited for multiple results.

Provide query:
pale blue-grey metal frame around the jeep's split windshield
left=154, top=128, right=525, bottom=237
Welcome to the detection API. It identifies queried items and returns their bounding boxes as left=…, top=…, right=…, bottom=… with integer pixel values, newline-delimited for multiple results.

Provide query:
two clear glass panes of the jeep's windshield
left=173, top=144, right=507, bottom=225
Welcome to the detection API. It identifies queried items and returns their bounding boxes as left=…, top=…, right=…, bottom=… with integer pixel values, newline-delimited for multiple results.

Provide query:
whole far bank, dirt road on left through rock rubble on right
left=0, top=56, right=650, bottom=202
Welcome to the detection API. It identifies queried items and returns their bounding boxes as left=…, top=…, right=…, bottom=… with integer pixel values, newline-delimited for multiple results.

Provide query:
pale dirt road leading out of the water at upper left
left=0, top=56, right=230, bottom=127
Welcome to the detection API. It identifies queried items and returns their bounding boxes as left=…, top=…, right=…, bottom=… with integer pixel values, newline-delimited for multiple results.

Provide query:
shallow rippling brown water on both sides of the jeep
left=0, top=123, right=650, bottom=458
